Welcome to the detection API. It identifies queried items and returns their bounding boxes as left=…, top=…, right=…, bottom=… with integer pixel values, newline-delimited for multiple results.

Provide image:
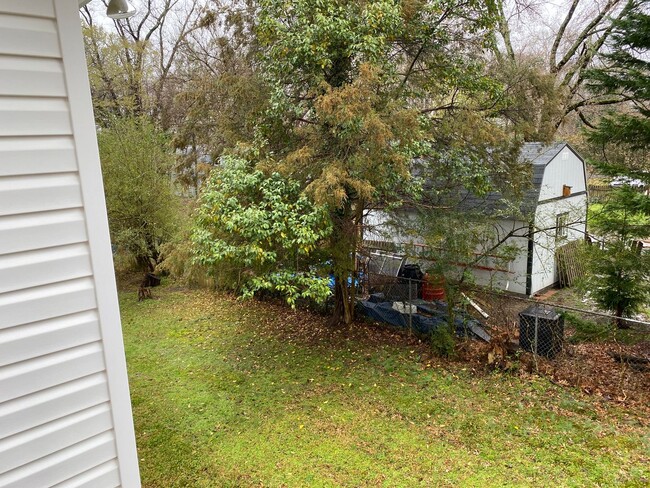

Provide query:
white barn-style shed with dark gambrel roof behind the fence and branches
left=364, top=142, right=587, bottom=296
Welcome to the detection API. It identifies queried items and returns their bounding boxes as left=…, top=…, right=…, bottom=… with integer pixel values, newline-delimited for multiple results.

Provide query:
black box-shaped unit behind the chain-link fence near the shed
left=519, top=304, right=564, bottom=358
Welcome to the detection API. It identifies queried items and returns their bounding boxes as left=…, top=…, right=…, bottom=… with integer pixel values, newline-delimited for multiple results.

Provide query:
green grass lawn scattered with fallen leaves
left=120, top=288, right=650, bottom=487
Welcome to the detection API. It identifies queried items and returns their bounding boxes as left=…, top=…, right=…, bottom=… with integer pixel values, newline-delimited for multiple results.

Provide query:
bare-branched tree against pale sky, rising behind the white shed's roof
left=493, top=0, right=625, bottom=141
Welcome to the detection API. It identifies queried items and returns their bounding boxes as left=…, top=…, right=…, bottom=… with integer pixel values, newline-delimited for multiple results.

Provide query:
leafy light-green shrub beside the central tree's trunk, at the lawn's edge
left=192, top=156, right=332, bottom=306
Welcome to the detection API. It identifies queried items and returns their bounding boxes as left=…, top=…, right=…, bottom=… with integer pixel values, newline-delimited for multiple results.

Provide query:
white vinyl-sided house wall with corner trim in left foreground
left=0, top=0, right=140, bottom=488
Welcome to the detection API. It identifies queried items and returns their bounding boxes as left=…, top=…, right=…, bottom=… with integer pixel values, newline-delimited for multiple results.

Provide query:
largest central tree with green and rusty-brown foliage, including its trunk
left=257, top=0, right=520, bottom=323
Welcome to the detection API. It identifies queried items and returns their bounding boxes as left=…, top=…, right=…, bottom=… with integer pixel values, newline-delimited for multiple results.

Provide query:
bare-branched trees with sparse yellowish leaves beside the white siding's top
left=81, top=0, right=205, bottom=128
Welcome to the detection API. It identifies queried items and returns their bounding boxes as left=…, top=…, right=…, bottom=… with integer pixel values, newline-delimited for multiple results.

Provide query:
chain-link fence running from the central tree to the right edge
left=360, top=272, right=650, bottom=402
